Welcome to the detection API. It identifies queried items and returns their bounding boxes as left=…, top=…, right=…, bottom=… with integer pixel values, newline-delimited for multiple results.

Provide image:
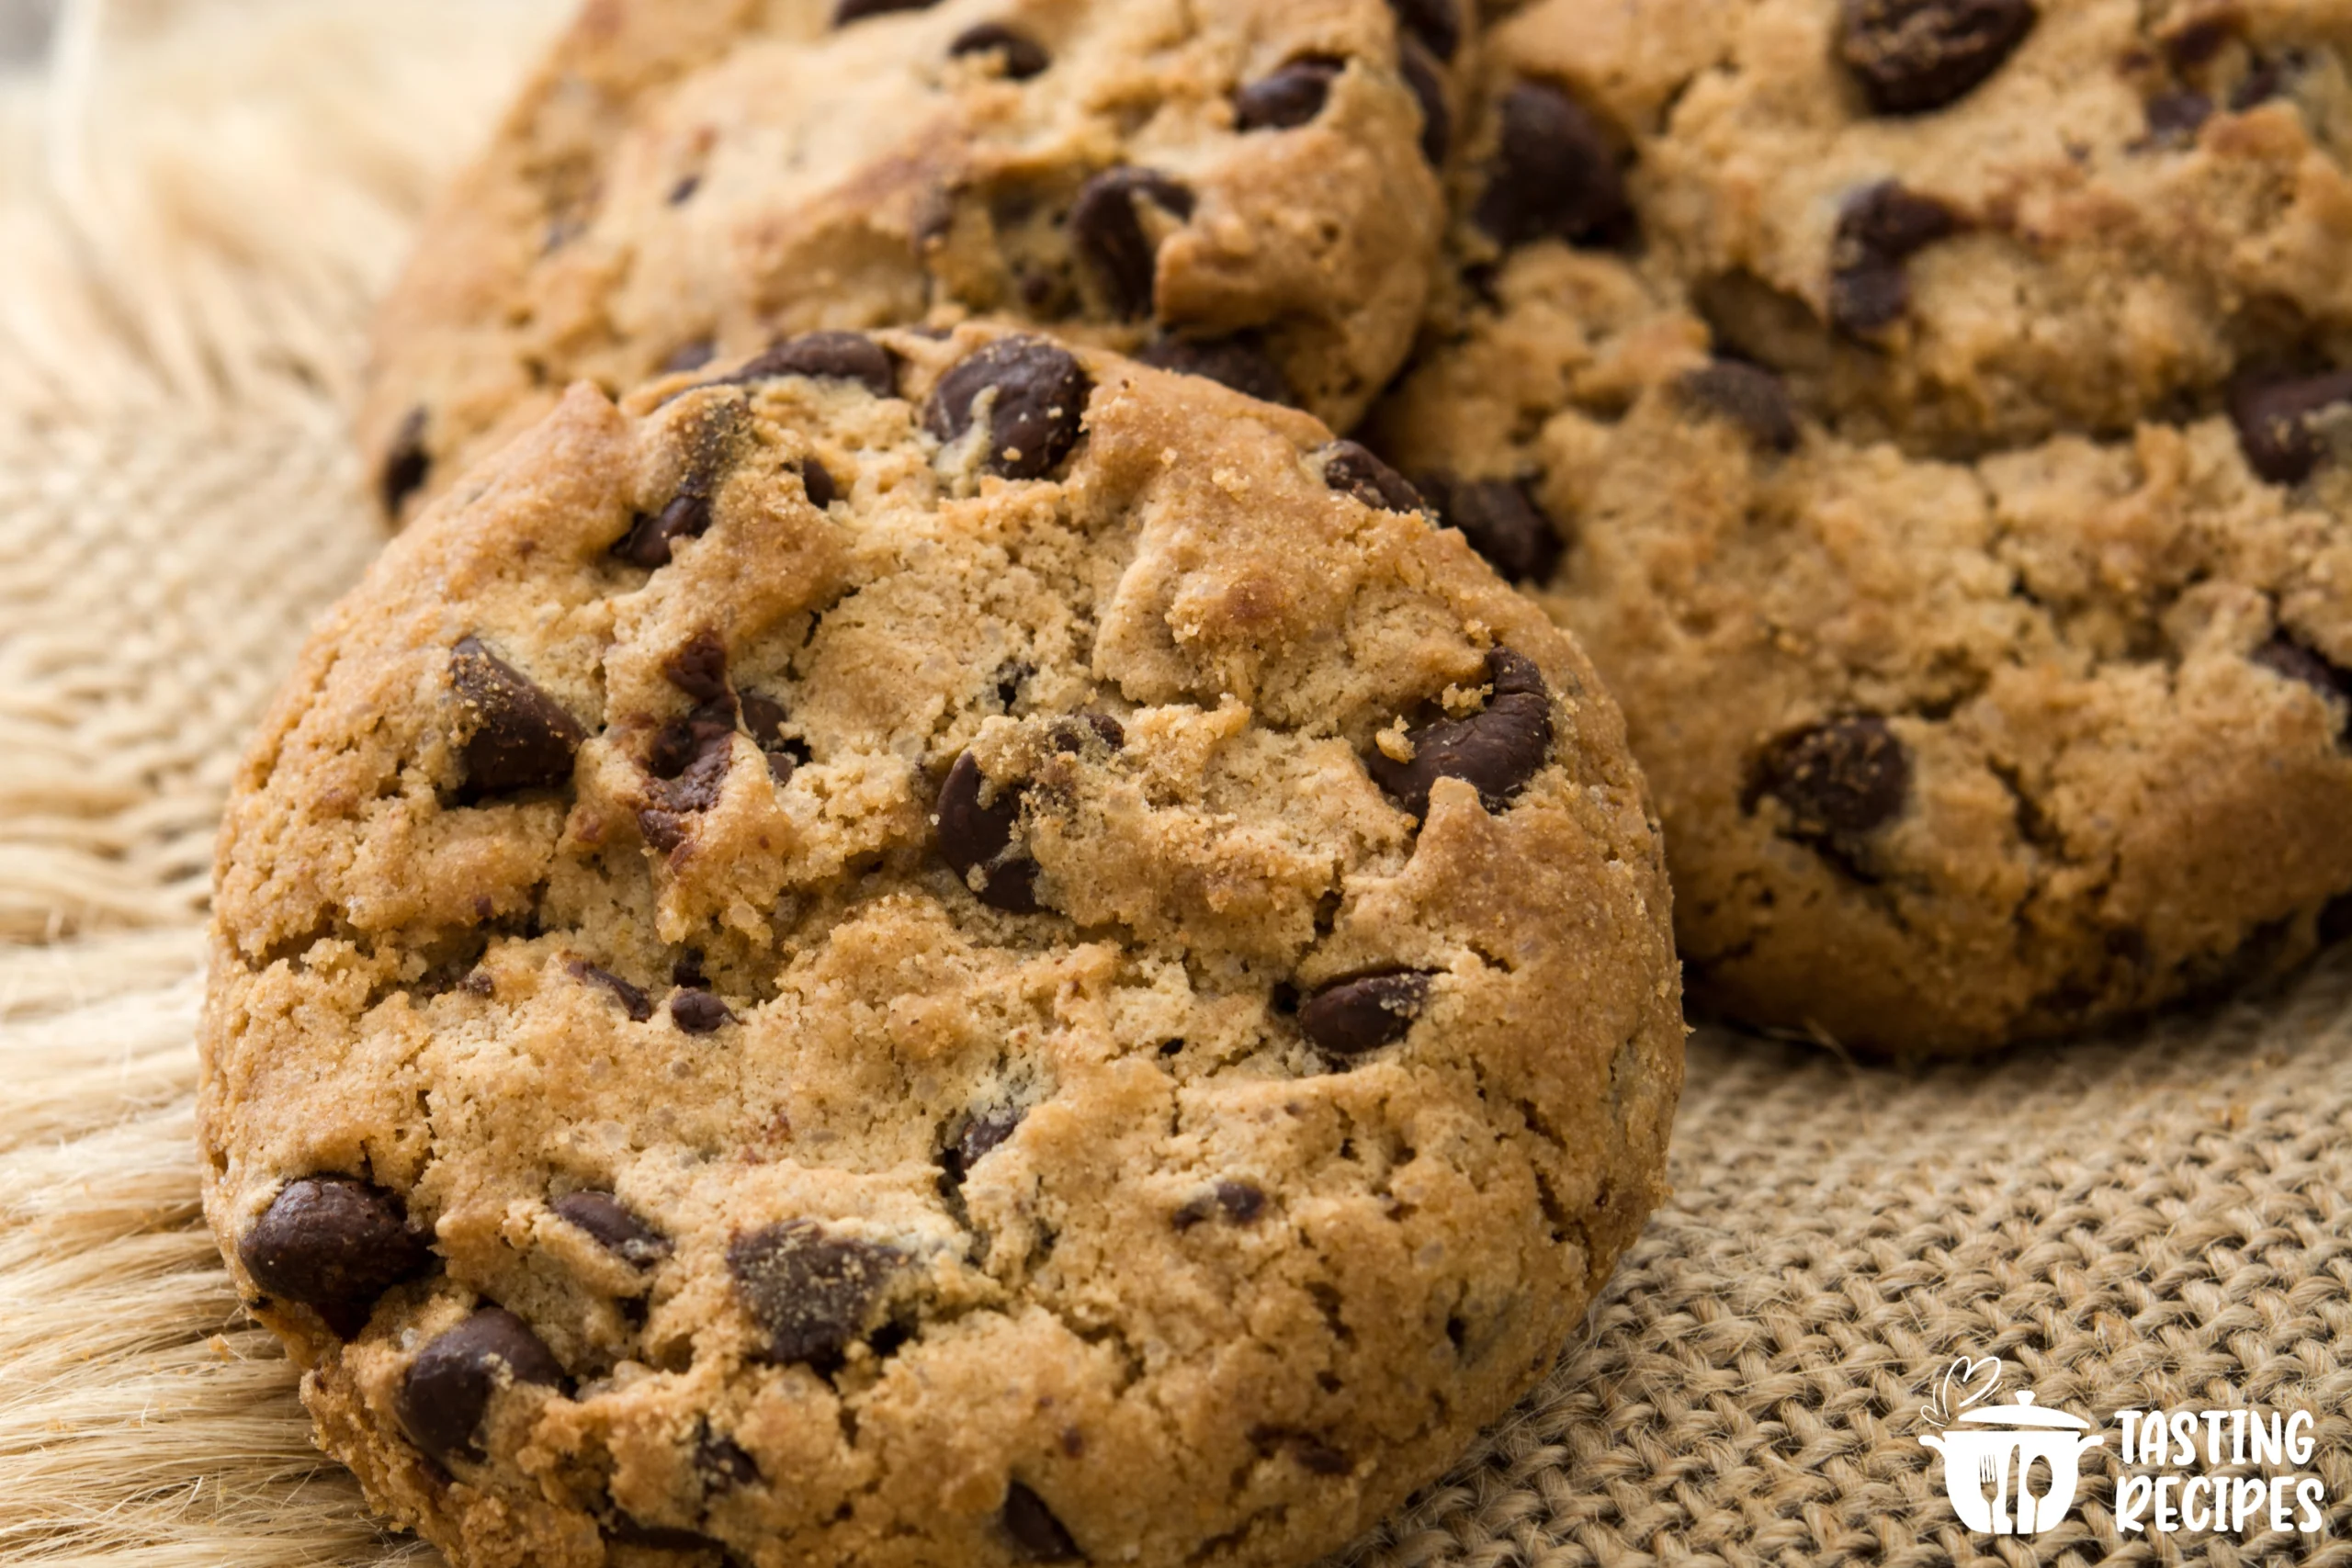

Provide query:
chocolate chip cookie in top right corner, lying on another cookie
left=1494, top=0, right=2352, bottom=458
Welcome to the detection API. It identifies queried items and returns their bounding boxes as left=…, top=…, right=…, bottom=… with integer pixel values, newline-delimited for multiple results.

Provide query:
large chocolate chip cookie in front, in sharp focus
left=202, top=327, right=1681, bottom=1568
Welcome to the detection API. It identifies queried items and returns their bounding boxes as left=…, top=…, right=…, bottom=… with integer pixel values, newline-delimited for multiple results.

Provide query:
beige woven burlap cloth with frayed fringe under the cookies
left=0, top=0, right=2352, bottom=1568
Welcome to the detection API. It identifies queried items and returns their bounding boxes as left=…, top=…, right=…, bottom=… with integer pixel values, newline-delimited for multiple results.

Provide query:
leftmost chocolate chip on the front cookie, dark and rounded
left=238, top=1176, right=433, bottom=1340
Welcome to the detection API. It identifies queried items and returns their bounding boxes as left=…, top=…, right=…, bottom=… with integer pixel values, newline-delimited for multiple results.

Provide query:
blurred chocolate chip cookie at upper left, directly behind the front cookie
left=360, top=0, right=1470, bottom=522
